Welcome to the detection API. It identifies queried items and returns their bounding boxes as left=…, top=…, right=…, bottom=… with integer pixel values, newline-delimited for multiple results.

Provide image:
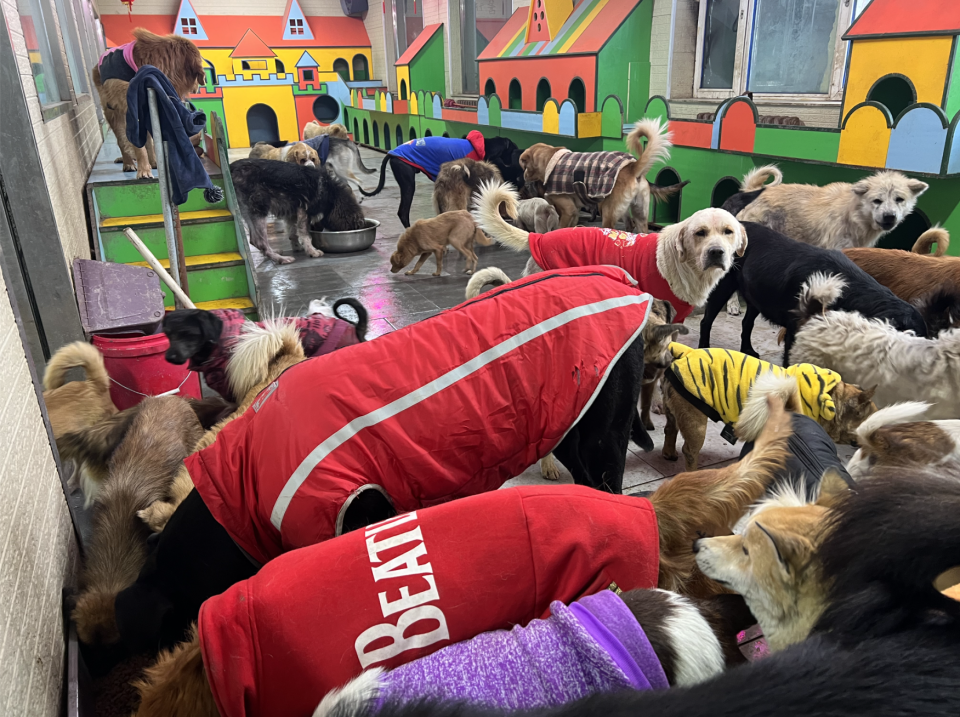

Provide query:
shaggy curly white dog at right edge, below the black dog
left=793, top=274, right=960, bottom=419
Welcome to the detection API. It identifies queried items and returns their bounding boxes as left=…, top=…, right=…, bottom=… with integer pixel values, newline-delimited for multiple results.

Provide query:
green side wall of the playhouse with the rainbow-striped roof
left=596, top=0, right=653, bottom=122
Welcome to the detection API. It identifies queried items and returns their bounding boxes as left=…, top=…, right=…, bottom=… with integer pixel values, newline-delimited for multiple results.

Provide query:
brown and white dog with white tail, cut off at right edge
left=847, top=401, right=960, bottom=479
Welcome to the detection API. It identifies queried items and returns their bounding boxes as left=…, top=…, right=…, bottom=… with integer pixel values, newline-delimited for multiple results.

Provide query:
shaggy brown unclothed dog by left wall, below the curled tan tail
left=72, top=396, right=203, bottom=645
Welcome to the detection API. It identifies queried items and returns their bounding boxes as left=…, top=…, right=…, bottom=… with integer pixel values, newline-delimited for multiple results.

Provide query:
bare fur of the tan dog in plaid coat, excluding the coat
left=520, top=119, right=673, bottom=232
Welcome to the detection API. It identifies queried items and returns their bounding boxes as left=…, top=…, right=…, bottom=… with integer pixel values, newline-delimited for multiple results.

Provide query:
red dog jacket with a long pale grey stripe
left=187, top=267, right=650, bottom=563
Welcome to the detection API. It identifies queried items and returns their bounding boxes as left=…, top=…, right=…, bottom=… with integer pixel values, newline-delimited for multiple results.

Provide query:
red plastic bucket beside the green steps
left=93, top=334, right=201, bottom=411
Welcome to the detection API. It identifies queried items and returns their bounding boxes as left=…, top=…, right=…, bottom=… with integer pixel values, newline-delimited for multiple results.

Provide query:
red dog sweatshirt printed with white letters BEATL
left=199, top=484, right=659, bottom=717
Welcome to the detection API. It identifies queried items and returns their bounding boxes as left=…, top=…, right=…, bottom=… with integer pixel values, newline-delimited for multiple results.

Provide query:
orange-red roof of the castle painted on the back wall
left=100, top=15, right=370, bottom=49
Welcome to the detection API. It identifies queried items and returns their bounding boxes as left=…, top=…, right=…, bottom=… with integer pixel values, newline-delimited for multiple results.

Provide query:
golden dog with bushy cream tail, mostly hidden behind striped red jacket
left=137, top=319, right=306, bottom=533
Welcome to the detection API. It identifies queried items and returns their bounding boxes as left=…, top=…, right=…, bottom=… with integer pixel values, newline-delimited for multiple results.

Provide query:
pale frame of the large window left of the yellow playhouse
left=693, top=0, right=862, bottom=103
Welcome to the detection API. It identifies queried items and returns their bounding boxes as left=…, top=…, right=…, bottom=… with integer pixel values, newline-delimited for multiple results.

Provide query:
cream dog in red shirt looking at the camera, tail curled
left=473, top=184, right=747, bottom=323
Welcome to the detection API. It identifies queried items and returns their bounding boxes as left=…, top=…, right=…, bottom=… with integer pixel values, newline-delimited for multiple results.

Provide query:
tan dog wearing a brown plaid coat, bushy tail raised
left=520, top=119, right=673, bottom=231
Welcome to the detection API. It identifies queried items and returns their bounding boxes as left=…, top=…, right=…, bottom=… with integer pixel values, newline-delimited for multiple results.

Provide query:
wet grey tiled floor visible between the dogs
left=231, top=148, right=840, bottom=492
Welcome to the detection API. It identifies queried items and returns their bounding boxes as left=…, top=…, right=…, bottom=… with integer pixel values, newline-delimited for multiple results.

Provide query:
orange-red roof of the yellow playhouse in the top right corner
left=843, top=0, right=960, bottom=40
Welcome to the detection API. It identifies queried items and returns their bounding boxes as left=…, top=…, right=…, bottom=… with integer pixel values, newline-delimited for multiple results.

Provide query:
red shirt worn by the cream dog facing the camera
left=529, top=227, right=693, bottom=323
